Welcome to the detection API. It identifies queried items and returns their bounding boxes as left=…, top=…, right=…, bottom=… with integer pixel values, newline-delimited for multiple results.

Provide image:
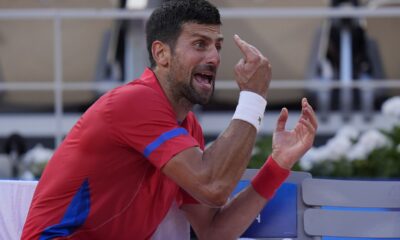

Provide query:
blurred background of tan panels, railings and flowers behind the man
left=0, top=0, right=400, bottom=179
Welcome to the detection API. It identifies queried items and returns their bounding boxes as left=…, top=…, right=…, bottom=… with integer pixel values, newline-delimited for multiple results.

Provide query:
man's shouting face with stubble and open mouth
left=168, top=23, right=223, bottom=104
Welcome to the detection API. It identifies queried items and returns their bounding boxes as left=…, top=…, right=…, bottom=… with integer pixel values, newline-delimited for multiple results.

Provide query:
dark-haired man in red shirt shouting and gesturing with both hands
left=22, top=0, right=317, bottom=239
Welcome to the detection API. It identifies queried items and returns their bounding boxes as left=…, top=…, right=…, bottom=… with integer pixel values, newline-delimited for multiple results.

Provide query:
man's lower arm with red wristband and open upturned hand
left=181, top=99, right=318, bottom=239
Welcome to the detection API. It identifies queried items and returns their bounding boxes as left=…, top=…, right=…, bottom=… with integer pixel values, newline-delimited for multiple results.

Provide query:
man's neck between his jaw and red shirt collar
left=153, top=67, right=193, bottom=122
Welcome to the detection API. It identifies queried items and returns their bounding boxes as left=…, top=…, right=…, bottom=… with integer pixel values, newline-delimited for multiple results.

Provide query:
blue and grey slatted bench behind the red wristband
left=234, top=169, right=400, bottom=240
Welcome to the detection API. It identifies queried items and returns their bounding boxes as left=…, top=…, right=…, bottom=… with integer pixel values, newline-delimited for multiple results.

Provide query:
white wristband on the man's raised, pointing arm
left=232, top=91, right=267, bottom=132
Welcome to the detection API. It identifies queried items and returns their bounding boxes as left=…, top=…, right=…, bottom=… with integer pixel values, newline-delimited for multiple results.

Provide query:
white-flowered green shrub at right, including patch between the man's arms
left=249, top=97, right=400, bottom=178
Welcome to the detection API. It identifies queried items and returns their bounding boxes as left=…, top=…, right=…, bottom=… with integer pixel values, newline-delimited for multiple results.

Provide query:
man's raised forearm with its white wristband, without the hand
left=195, top=91, right=267, bottom=204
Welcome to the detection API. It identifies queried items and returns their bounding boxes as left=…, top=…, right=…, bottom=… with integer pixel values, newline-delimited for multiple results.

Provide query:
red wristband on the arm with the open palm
left=251, top=156, right=290, bottom=200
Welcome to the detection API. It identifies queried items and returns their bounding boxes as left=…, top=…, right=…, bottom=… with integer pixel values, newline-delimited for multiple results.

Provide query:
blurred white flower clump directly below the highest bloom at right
left=346, top=129, right=392, bottom=160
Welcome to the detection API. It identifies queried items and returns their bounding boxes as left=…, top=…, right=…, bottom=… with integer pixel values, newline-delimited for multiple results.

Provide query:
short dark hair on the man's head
left=146, top=0, right=221, bottom=68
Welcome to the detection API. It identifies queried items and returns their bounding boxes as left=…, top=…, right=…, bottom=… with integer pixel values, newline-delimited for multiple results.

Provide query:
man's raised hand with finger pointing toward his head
left=233, top=34, right=271, bottom=98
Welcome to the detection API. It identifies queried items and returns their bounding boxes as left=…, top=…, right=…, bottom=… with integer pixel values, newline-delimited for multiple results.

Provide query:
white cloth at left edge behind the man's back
left=0, top=180, right=37, bottom=240
